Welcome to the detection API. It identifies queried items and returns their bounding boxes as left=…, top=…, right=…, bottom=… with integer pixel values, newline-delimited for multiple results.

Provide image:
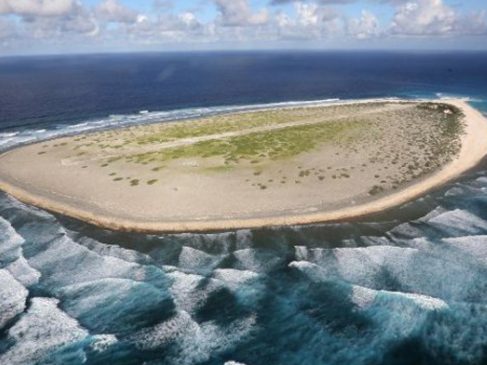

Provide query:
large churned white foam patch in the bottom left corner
left=0, top=298, right=88, bottom=365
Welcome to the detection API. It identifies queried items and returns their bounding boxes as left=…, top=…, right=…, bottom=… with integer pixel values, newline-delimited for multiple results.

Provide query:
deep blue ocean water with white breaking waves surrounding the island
left=0, top=52, right=487, bottom=365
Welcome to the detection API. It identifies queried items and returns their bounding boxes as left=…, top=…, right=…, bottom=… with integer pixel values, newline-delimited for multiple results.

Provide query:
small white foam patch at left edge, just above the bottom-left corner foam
left=0, top=270, right=29, bottom=328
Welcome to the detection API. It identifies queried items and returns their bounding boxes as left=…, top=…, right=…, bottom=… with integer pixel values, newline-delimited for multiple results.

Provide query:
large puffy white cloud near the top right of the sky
left=391, top=0, right=457, bottom=35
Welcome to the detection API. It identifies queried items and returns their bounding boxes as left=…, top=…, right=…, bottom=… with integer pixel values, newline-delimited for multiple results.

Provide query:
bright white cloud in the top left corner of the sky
left=0, top=0, right=77, bottom=16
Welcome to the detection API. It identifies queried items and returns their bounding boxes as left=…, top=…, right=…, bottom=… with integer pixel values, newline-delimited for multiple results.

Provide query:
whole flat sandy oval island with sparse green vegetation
left=0, top=100, right=487, bottom=233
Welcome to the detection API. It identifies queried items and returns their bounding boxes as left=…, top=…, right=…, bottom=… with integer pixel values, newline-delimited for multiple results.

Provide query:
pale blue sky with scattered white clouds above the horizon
left=0, top=0, right=487, bottom=56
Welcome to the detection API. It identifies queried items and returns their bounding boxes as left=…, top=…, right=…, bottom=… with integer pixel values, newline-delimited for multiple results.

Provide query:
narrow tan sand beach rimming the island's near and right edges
left=0, top=99, right=487, bottom=233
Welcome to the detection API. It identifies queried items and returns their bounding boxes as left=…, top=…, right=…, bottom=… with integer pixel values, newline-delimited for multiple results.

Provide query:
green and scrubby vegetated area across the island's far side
left=46, top=102, right=464, bottom=195
